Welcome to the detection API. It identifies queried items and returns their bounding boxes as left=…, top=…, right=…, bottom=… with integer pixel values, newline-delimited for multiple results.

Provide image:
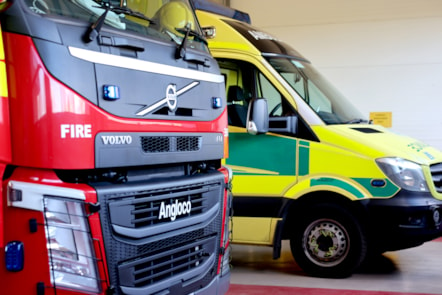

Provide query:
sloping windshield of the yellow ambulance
left=266, top=56, right=368, bottom=124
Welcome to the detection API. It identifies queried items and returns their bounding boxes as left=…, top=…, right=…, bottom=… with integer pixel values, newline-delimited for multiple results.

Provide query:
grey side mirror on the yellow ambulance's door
left=246, top=98, right=269, bottom=135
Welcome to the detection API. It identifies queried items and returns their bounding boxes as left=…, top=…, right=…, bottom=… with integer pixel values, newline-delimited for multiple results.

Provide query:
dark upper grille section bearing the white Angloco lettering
left=109, top=178, right=221, bottom=238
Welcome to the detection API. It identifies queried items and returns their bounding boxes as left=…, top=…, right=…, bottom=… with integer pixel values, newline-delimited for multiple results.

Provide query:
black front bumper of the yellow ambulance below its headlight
left=366, top=190, right=442, bottom=251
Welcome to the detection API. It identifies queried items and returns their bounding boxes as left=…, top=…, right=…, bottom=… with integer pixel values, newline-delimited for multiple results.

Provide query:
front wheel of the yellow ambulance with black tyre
left=290, top=204, right=367, bottom=278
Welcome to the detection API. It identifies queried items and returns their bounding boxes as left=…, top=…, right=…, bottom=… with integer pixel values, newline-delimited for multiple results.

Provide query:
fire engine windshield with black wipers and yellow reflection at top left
left=25, top=0, right=207, bottom=51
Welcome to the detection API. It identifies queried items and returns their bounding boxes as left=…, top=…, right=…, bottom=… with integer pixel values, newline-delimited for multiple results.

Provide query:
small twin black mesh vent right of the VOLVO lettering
left=141, top=136, right=202, bottom=153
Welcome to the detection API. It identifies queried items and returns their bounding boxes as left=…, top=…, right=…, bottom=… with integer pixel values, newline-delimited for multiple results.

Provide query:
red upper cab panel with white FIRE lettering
left=4, top=33, right=98, bottom=168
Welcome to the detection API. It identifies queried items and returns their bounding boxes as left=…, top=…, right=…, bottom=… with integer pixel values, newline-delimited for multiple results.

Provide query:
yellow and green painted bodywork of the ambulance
left=197, top=11, right=442, bottom=251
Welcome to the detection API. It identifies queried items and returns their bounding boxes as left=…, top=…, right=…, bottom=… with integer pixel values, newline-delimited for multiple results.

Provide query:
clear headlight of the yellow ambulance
left=376, top=158, right=429, bottom=192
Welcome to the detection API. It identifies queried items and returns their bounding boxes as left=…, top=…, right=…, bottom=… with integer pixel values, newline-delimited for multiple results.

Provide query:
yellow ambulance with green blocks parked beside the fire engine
left=197, top=5, right=442, bottom=277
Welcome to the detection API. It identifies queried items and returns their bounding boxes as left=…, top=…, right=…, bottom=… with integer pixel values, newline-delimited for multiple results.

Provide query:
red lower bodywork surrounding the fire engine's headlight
left=0, top=167, right=107, bottom=295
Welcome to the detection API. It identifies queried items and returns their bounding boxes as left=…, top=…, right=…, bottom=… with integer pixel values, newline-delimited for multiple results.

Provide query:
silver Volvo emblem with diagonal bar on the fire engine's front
left=135, top=81, right=200, bottom=116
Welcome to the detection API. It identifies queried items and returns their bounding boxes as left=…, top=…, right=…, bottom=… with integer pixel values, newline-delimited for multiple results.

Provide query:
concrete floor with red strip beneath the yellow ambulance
left=227, top=239, right=442, bottom=295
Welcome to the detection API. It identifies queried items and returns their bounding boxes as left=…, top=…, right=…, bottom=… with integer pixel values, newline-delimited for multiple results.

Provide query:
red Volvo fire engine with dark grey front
left=0, top=0, right=231, bottom=295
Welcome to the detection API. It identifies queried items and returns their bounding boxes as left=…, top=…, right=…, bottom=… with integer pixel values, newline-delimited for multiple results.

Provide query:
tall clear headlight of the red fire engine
left=44, top=197, right=100, bottom=293
